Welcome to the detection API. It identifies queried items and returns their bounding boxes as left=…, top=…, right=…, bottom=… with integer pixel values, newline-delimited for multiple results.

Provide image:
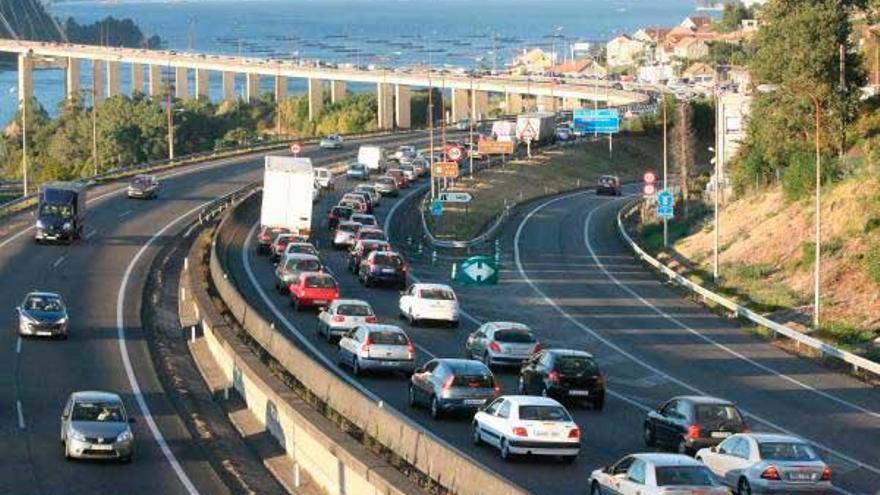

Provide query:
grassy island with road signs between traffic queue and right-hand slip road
left=426, top=136, right=662, bottom=240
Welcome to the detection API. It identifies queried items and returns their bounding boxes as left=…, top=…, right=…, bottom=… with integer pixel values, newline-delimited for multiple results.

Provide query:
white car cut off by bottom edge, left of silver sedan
left=588, top=453, right=728, bottom=495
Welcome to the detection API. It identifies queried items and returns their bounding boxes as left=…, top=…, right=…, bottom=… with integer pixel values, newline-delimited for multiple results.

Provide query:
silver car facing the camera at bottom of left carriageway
left=61, top=391, right=134, bottom=462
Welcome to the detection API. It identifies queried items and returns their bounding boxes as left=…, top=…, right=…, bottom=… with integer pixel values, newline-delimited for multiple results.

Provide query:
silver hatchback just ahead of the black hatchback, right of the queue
left=465, top=321, right=541, bottom=368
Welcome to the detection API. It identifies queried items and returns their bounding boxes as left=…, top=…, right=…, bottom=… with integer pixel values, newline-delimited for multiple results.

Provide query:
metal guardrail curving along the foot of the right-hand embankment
left=617, top=201, right=880, bottom=378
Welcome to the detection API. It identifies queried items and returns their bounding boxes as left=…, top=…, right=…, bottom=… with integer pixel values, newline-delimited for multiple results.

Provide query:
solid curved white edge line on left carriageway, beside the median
left=116, top=201, right=211, bottom=495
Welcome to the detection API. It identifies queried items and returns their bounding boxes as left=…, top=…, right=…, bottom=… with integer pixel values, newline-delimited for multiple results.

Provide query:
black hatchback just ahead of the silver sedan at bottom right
left=643, top=396, right=748, bottom=454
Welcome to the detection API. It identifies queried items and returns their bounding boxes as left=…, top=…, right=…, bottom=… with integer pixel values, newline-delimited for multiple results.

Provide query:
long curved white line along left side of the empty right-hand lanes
left=513, top=192, right=880, bottom=480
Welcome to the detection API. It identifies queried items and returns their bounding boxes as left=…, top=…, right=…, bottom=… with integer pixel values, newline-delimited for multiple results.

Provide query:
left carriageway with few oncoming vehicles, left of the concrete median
left=0, top=134, right=424, bottom=494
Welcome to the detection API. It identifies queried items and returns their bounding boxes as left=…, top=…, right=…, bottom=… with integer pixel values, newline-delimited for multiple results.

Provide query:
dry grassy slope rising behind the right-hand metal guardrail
left=639, top=172, right=880, bottom=361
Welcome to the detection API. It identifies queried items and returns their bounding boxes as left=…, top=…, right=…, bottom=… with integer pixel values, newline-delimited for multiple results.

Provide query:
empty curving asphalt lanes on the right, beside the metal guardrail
left=521, top=192, right=880, bottom=489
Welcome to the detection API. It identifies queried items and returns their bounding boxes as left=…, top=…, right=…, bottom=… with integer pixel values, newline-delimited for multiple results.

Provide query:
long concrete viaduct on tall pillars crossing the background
left=0, top=39, right=646, bottom=129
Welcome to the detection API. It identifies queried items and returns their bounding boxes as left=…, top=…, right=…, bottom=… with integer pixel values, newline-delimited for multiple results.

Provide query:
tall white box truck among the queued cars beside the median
left=260, top=155, right=315, bottom=235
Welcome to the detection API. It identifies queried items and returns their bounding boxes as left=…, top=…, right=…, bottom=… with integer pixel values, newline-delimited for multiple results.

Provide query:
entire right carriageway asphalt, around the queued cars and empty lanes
left=223, top=176, right=880, bottom=494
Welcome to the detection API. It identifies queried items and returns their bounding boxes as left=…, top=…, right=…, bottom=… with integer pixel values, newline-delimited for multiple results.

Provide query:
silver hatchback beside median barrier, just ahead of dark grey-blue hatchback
left=337, top=324, right=416, bottom=376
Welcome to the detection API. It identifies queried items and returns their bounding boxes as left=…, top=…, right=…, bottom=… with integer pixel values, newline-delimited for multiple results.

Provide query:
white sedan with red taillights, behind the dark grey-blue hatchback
left=473, top=395, right=582, bottom=463
